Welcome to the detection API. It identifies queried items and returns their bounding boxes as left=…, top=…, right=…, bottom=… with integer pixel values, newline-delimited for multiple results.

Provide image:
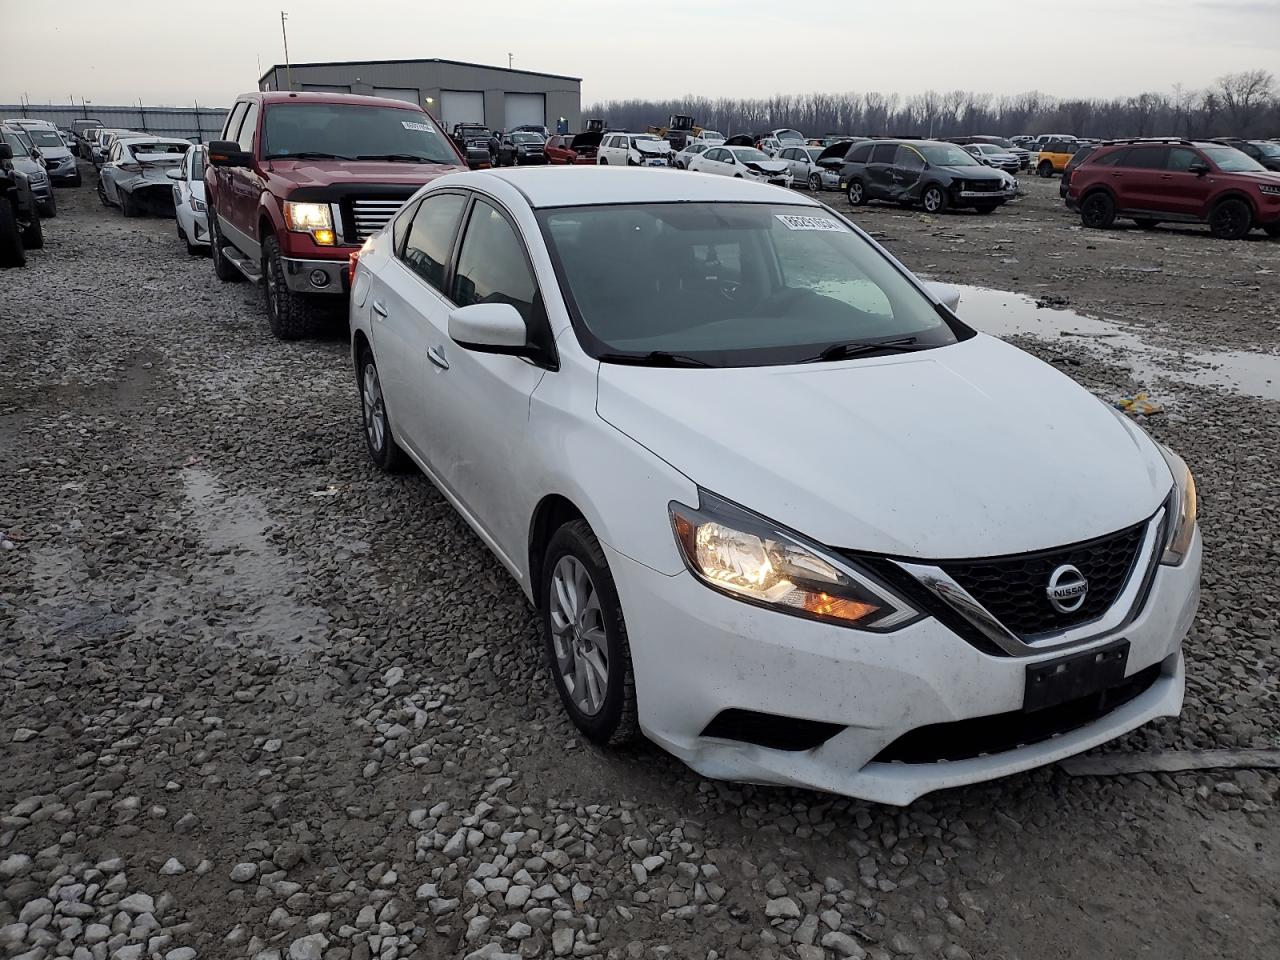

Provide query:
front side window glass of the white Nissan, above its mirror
left=453, top=200, right=538, bottom=326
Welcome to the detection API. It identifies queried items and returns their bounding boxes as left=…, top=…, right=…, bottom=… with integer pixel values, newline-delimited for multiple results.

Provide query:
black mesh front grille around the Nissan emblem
left=940, top=524, right=1146, bottom=639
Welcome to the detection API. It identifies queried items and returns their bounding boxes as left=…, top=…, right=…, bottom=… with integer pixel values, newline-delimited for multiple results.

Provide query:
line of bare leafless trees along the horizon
left=582, top=69, right=1280, bottom=138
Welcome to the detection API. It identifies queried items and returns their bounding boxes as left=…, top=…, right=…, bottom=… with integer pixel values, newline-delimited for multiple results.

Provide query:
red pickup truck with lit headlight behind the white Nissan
left=205, top=91, right=467, bottom=340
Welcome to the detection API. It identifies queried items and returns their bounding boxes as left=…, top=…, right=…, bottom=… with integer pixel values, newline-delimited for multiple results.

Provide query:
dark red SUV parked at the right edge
left=1066, top=140, right=1280, bottom=239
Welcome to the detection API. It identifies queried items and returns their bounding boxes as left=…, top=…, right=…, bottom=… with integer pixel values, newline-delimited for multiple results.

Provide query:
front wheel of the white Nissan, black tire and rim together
left=539, top=520, right=640, bottom=745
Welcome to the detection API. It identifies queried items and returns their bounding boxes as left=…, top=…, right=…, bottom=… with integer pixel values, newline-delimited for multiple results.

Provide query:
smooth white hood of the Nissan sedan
left=596, top=334, right=1172, bottom=559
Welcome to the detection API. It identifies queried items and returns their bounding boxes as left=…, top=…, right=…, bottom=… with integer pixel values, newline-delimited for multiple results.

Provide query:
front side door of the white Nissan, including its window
left=429, top=196, right=552, bottom=568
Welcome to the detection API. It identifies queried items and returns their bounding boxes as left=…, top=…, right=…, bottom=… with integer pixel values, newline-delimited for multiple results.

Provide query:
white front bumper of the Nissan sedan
left=607, top=534, right=1201, bottom=805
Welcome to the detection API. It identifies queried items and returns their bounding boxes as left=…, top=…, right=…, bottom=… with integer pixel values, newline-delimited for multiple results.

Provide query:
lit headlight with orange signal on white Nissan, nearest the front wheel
left=671, top=490, right=922, bottom=632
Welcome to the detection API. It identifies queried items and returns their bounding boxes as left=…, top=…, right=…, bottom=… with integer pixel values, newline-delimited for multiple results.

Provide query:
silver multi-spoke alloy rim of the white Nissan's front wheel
left=549, top=556, right=609, bottom=717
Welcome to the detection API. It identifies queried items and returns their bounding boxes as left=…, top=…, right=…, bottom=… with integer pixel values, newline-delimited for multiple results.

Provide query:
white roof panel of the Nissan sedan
left=431, top=166, right=820, bottom=209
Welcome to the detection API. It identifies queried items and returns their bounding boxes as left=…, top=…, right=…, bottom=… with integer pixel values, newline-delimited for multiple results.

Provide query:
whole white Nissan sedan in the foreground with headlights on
left=351, top=168, right=1201, bottom=804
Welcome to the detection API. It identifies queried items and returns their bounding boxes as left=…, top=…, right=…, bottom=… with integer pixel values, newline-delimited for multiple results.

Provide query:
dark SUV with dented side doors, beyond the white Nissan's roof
left=840, top=140, right=1018, bottom=214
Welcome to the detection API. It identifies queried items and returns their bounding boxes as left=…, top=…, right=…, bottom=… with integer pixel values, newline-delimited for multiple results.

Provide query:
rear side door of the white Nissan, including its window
left=369, top=192, right=467, bottom=463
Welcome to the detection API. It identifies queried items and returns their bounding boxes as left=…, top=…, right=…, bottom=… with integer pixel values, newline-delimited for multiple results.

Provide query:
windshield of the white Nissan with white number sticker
left=538, top=202, right=963, bottom=366
